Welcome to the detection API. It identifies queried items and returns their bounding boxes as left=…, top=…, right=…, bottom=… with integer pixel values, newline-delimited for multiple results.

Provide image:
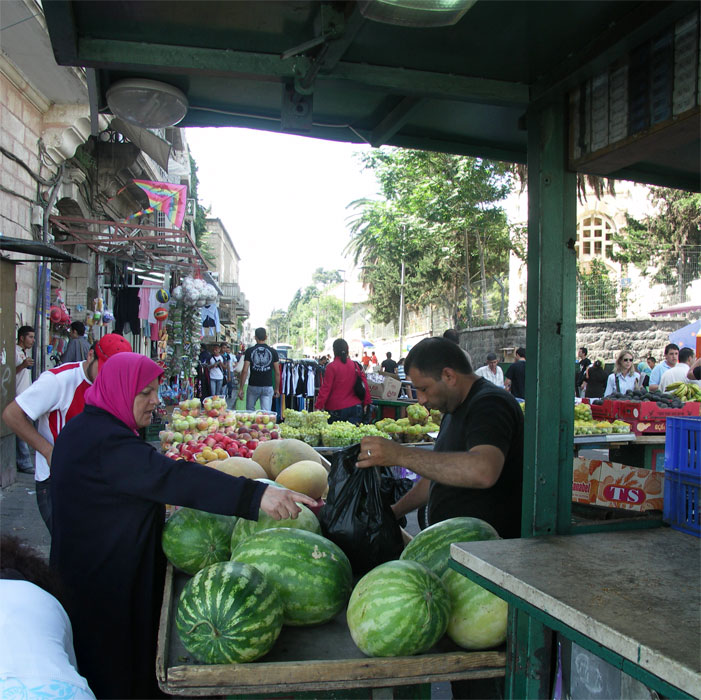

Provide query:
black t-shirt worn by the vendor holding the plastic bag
left=428, top=380, right=523, bottom=538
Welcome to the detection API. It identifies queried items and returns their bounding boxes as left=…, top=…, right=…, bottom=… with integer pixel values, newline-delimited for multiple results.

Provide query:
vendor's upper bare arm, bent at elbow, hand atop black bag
left=357, top=437, right=504, bottom=489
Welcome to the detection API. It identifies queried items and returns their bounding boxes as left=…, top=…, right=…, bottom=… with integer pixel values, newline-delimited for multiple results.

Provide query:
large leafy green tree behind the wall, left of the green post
left=346, top=148, right=511, bottom=326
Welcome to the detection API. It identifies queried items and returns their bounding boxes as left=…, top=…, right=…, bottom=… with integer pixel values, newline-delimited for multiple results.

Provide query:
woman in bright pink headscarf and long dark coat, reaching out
left=51, top=352, right=314, bottom=698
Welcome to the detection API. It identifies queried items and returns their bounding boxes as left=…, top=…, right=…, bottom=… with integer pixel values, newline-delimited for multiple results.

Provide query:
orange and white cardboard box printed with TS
left=572, top=457, right=664, bottom=512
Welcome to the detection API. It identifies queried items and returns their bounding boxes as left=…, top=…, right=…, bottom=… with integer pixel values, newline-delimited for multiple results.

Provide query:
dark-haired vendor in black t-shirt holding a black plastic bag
left=358, top=338, right=523, bottom=538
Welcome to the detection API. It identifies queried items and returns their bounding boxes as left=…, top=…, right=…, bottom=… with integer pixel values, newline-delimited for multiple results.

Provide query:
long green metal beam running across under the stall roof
left=72, top=37, right=528, bottom=106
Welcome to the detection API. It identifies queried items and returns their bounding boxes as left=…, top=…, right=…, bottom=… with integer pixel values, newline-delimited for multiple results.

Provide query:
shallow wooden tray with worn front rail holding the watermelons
left=156, top=564, right=506, bottom=697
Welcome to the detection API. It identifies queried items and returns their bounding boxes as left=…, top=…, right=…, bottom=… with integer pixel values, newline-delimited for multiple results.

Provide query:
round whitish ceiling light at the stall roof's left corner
left=107, top=78, right=188, bottom=129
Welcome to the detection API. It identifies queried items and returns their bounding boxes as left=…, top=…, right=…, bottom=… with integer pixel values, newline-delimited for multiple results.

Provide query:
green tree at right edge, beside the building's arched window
left=614, top=187, right=701, bottom=297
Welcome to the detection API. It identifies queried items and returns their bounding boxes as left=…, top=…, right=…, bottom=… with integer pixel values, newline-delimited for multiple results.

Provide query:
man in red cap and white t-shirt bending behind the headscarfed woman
left=2, top=333, right=131, bottom=532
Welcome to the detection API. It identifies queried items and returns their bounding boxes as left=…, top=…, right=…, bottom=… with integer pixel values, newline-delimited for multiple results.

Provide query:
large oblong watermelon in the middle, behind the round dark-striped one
left=231, top=527, right=351, bottom=627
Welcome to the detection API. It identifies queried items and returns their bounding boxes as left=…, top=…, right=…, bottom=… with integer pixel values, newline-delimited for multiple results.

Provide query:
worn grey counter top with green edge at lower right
left=451, top=528, right=701, bottom=697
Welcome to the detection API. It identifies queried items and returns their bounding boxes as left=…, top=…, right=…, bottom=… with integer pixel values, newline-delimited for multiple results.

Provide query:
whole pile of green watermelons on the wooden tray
left=163, top=506, right=507, bottom=664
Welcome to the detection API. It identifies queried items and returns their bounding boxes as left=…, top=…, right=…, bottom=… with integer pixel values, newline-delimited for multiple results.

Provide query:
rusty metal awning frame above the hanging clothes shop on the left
left=49, top=216, right=208, bottom=272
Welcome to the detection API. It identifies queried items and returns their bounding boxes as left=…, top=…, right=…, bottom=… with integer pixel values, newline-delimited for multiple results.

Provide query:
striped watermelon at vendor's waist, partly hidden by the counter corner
left=399, top=517, right=499, bottom=577
